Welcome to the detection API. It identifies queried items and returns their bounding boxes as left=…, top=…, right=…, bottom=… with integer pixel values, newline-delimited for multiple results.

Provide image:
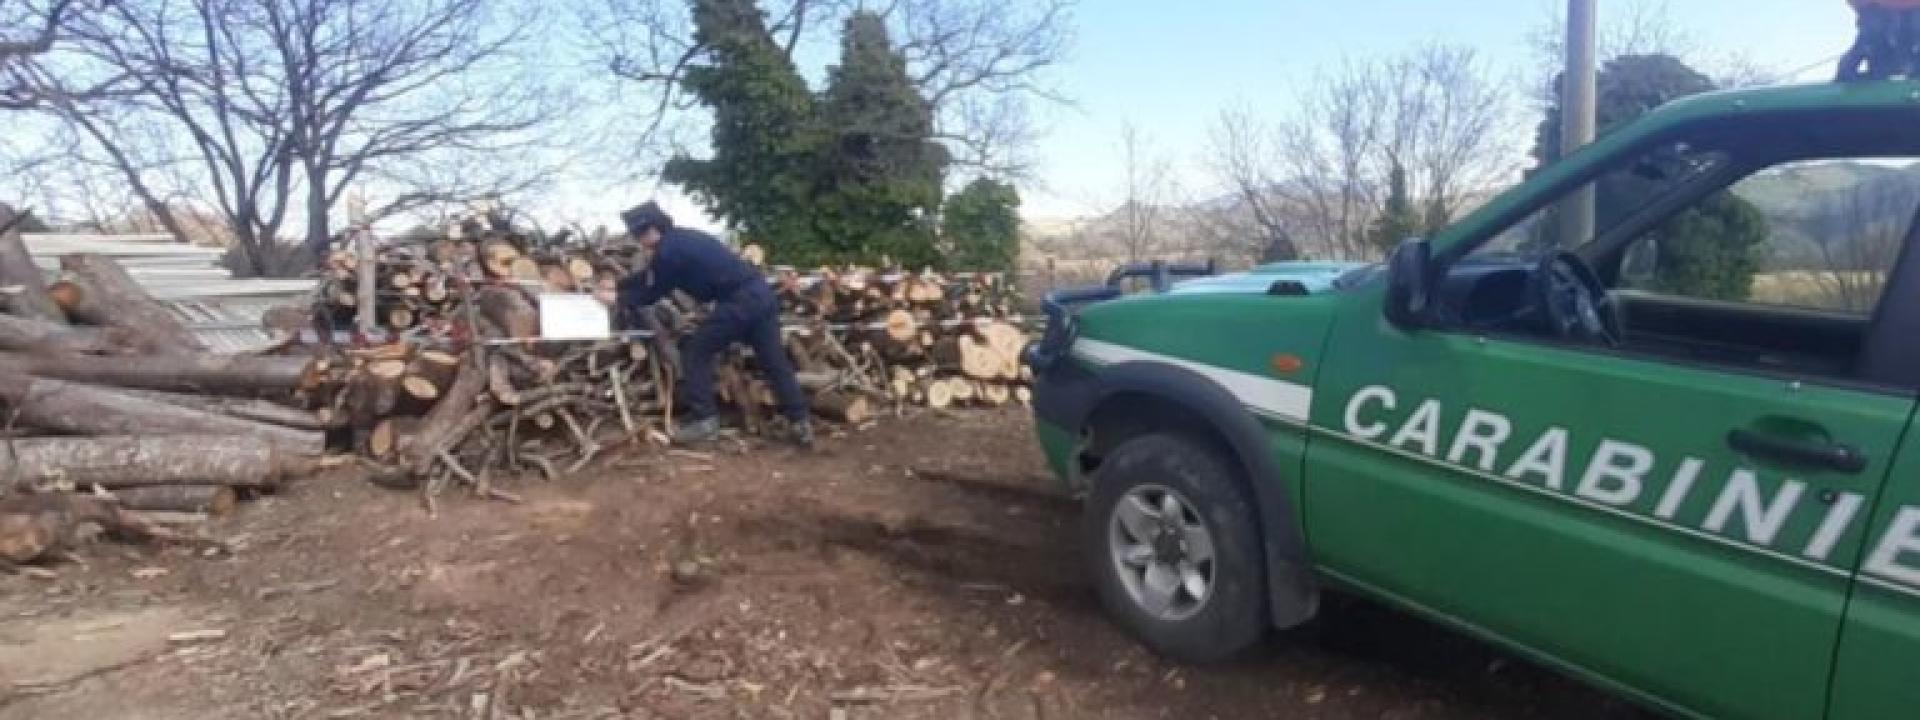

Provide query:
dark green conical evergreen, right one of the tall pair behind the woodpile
left=814, top=12, right=947, bottom=267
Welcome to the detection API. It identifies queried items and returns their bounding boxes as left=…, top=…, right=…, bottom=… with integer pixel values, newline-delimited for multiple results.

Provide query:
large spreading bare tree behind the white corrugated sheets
left=39, top=0, right=547, bottom=273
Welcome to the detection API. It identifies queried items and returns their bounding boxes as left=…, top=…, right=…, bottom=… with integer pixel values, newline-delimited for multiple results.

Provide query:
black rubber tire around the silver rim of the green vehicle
left=1083, top=434, right=1267, bottom=664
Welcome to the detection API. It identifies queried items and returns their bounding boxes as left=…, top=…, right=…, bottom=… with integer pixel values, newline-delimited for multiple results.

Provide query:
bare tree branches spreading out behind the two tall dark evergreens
left=582, top=0, right=1077, bottom=177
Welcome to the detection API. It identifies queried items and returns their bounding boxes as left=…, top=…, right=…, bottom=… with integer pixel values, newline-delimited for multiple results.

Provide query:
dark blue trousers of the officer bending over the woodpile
left=680, top=282, right=806, bottom=420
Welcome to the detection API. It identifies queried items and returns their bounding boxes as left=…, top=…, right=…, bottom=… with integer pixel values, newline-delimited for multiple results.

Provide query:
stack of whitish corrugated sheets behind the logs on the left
left=23, top=234, right=315, bottom=353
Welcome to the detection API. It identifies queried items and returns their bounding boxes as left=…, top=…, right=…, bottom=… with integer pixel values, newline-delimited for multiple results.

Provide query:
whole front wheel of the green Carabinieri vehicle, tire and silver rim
left=1083, top=434, right=1267, bottom=662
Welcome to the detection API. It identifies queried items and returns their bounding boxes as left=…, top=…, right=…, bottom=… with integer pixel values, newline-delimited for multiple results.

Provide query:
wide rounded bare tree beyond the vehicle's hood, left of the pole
left=1210, top=46, right=1517, bottom=259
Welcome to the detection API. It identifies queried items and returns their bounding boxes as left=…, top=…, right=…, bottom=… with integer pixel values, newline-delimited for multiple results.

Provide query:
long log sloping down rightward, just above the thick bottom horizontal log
left=0, top=371, right=326, bottom=455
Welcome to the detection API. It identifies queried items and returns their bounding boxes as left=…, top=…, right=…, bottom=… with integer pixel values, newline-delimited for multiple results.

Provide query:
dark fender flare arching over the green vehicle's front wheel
left=1071, top=361, right=1319, bottom=628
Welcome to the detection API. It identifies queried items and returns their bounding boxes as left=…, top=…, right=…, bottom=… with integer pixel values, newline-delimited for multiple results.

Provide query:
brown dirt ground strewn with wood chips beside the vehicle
left=0, top=411, right=1638, bottom=720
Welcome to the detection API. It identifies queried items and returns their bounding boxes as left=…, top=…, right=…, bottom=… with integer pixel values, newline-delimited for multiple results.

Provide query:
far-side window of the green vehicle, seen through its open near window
left=1620, top=157, right=1920, bottom=317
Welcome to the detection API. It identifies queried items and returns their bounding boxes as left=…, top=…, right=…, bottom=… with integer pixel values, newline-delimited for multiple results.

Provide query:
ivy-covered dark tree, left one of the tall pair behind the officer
left=664, top=0, right=826, bottom=263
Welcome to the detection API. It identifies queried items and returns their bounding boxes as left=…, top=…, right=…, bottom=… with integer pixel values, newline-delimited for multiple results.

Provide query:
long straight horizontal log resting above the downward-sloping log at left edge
left=0, top=353, right=313, bottom=396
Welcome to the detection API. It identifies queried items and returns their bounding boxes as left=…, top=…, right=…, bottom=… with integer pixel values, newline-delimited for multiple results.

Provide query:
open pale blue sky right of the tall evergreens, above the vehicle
left=1025, top=0, right=1853, bottom=215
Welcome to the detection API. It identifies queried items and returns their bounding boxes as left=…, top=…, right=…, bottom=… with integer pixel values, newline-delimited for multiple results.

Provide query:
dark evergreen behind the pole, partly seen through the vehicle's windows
left=1534, top=56, right=1768, bottom=300
